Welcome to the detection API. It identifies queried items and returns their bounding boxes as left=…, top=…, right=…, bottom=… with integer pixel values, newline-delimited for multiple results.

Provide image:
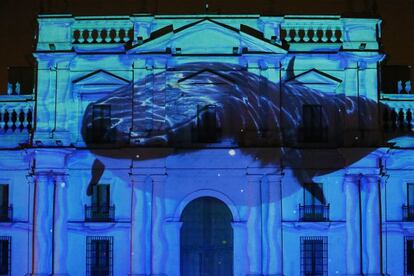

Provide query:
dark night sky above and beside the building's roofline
left=0, top=0, right=414, bottom=93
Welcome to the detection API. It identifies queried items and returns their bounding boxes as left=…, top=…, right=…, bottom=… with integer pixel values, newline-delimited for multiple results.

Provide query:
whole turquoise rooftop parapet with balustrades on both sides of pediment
left=37, top=14, right=381, bottom=52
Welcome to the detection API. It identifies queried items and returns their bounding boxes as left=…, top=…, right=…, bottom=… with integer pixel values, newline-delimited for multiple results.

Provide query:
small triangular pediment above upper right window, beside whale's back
left=286, top=69, right=342, bottom=93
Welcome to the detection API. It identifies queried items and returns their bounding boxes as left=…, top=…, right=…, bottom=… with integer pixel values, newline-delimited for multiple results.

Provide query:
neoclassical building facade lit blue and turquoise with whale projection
left=0, top=14, right=414, bottom=276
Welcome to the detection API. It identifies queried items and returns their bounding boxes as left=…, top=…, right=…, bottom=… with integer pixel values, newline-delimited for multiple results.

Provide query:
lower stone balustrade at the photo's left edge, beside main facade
left=0, top=96, right=34, bottom=134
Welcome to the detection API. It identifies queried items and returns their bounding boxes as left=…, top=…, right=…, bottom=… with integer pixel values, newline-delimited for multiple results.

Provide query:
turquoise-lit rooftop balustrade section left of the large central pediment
left=71, top=16, right=133, bottom=44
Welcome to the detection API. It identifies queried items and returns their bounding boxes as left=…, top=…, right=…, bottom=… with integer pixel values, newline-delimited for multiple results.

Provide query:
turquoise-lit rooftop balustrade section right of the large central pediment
left=280, top=17, right=343, bottom=43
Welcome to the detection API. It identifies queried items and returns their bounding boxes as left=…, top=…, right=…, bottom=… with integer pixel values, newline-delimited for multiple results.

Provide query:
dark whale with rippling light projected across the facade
left=82, top=60, right=392, bottom=202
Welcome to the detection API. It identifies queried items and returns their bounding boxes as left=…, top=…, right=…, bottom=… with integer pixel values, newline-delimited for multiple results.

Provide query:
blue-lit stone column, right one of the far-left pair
left=53, top=175, right=69, bottom=276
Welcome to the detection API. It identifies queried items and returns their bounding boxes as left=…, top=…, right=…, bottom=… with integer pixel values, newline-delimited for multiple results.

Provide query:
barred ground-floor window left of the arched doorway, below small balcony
left=86, top=236, right=113, bottom=276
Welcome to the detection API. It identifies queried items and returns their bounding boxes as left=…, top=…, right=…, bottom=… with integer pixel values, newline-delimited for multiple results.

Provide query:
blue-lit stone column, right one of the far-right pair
left=362, top=175, right=382, bottom=275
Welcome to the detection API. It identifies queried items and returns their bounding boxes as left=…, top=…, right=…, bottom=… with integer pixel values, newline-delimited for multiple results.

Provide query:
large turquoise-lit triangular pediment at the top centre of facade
left=128, top=18, right=287, bottom=55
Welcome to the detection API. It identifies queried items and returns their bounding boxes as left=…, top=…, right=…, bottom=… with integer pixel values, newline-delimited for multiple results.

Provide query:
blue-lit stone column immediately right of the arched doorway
left=246, top=175, right=263, bottom=275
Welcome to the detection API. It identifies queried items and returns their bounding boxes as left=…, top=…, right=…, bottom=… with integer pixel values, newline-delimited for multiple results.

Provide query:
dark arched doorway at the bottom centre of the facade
left=180, top=197, right=233, bottom=276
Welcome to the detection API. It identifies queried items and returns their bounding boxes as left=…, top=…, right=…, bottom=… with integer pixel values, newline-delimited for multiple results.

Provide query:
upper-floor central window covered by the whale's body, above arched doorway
left=197, top=105, right=218, bottom=143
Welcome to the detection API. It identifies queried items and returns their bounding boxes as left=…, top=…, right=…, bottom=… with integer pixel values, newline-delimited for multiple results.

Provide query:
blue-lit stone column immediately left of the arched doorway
left=151, top=175, right=168, bottom=276
